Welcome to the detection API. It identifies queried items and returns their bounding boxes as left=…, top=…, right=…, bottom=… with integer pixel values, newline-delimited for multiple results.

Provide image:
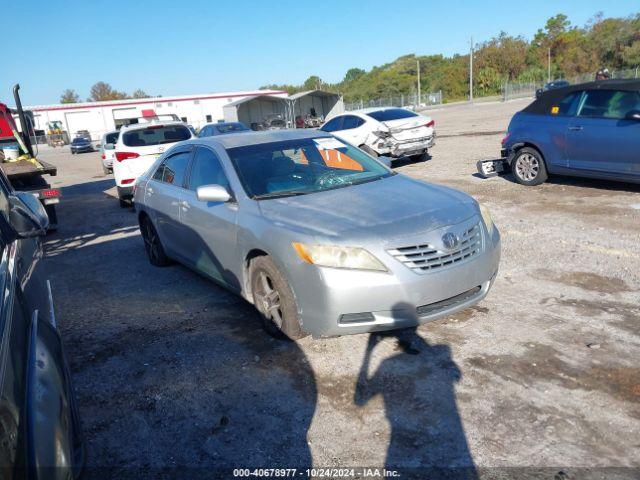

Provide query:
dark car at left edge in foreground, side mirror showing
left=0, top=169, right=84, bottom=479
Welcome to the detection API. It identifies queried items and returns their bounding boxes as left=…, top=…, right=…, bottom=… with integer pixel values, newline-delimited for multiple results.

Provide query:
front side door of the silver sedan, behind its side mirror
left=180, top=146, right=241, bottom=290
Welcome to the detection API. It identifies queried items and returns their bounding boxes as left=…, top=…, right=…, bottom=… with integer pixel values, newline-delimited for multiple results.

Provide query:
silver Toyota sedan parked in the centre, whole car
left=134, top=130, right=500, bottom=339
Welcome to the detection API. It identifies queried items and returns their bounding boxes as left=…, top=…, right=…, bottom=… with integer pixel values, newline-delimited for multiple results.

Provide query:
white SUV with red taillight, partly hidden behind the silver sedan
left=113, top=122, right=194, bottom=208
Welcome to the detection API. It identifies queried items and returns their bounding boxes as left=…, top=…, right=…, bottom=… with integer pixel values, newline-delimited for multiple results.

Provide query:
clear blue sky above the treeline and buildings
left=0, top=0, right=640, bottom=105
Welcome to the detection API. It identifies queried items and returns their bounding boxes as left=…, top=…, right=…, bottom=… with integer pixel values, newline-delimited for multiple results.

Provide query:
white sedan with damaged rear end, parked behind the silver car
left=320, top=107, right=436, bottom=160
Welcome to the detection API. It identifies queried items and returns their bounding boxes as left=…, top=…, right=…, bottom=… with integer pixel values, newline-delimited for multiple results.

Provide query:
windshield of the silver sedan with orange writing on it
left=228, top=138, right=393, bottom=199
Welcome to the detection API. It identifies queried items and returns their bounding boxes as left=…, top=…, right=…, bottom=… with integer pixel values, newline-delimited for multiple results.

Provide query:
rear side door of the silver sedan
left=145, top=145, right=193, bottom=259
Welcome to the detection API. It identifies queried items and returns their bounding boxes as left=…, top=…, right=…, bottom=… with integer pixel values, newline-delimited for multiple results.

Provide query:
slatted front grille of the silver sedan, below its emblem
left=387, top=223, right=482, bottom=273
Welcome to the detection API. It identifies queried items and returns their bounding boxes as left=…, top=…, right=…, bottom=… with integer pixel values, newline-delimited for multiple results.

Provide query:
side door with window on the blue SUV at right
left=567, top=90, right=640, bottom=176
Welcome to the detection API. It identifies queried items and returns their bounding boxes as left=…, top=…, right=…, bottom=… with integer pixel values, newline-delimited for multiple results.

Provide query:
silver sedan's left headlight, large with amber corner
left=292, top=242, right=387, bottom=272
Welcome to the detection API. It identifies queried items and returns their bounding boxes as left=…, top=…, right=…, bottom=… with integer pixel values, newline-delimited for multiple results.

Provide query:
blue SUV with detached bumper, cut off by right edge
left=478, top=80, right=640, bottom=185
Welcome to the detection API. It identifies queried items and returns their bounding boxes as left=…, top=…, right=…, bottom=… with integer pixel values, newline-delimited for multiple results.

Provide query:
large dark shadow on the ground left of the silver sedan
left=46, top=175, right=317, bottom=472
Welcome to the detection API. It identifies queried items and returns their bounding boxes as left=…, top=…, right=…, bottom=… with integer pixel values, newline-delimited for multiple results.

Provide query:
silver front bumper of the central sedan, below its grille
left=292, top=223, right=500, bottom=337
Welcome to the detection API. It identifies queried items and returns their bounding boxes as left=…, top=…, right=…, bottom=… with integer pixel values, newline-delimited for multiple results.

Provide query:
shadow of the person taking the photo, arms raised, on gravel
left=354, top=304, right=478, bottom=479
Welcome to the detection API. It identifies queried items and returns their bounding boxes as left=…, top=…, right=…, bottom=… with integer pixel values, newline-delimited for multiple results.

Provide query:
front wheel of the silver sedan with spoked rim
left=250, top=256, right=308, bottom=340
